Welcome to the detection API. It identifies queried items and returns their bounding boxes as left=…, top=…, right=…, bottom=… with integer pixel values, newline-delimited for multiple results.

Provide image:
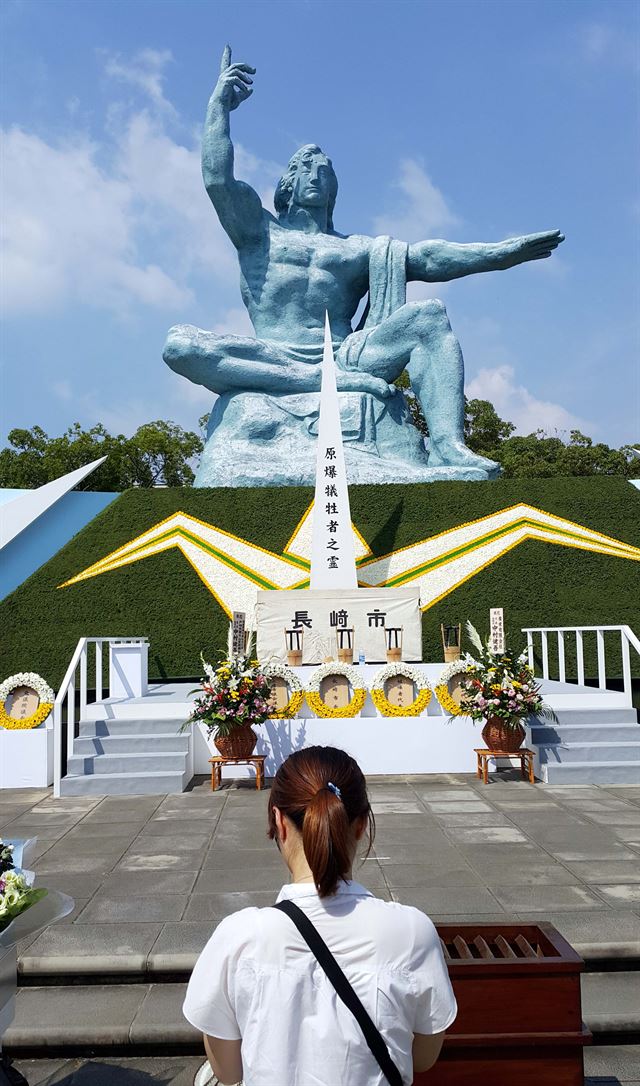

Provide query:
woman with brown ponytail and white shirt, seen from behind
left=184, top=746, right=456, bottom=1086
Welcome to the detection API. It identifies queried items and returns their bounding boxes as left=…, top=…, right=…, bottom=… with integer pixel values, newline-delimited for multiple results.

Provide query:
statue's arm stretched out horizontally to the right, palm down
left=406, top=230, right=564, bottom=282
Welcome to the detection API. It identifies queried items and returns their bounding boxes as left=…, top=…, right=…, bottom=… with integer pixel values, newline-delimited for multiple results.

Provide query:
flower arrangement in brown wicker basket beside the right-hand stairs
left=460, top=622, right=555, bottom=753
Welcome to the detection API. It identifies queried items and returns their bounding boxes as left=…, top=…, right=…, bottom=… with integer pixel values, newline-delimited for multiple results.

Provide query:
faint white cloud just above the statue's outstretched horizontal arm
left=374, top=159, right=460, bottom=241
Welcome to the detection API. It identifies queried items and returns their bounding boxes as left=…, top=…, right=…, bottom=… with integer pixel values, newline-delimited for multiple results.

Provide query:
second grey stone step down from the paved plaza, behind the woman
left=3, top=972, right=640, bottom=1055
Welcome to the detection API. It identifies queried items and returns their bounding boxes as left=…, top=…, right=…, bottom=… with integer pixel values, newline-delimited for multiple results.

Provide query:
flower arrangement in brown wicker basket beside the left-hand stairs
left=183, top=637, right=272, bottom=758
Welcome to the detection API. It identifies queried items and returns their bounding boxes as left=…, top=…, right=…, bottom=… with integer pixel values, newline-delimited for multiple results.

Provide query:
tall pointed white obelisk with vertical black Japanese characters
left=311, top=313, right=357, bottom=590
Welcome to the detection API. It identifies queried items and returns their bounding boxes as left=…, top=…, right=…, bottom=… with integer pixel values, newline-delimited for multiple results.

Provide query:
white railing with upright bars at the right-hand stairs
left=523, top=626, right=640, bottom=706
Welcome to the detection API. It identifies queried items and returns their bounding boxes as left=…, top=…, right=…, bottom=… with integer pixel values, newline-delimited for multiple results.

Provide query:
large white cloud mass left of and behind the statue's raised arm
left=2, top=50, right=279, bottom=316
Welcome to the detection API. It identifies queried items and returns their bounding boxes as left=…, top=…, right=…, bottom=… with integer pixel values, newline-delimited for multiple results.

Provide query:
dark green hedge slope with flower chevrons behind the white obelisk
left=0, top=478, right=640, bottom=685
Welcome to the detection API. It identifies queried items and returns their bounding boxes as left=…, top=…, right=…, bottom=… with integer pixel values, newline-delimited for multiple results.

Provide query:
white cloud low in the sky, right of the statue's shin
left=465, top=365, right=591, bottom=437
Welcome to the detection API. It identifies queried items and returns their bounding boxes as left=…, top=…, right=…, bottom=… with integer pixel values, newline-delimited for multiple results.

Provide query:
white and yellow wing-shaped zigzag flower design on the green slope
left=60, top=504, right=640, bottom=615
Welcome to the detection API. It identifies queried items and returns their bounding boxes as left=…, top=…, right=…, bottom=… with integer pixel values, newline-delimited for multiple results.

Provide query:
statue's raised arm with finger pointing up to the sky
left=202, top=46, right=264, bottom=249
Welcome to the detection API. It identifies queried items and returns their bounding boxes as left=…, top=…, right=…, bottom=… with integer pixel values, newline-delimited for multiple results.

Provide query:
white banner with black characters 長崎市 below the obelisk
left=256, top=589, right=423, bottom=664
